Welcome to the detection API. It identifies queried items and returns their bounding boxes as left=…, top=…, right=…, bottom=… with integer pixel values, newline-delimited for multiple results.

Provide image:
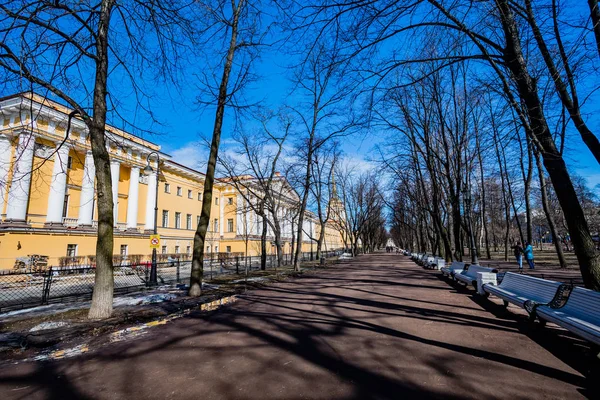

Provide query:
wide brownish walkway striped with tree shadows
left=0, top=254, right=598, bottom=400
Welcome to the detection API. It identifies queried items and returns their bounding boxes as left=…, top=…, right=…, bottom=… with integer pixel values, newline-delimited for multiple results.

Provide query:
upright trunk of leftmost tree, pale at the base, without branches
left=88, top=0, right=119, bottom=319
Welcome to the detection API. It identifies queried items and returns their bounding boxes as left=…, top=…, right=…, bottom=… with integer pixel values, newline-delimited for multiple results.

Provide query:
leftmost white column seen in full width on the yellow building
left=6, top=133, right=35, bottom=221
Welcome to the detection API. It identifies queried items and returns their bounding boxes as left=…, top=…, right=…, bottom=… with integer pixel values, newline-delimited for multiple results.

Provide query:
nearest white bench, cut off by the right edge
left=535, top=287, right=600, bottom=346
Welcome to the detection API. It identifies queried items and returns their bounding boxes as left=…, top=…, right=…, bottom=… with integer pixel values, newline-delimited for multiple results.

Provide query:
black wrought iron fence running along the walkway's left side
left=0, top=251, right=341, bottom=313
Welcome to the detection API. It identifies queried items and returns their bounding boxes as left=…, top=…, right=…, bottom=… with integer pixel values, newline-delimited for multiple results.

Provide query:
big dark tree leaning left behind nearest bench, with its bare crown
left=297, top=0, right=600, bottom=290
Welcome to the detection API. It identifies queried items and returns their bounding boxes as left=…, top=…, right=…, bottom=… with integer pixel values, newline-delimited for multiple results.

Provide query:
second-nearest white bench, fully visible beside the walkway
left=483, top=272, right=561, bottom=308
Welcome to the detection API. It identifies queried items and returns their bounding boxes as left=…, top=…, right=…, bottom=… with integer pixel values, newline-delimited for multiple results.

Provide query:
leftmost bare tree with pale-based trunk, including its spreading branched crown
left=0, top=0, right=192, bottom=319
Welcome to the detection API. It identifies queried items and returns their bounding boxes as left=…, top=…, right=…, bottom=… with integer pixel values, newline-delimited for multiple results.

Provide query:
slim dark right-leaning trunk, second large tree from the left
left=188, top=0, right=244, bottom=297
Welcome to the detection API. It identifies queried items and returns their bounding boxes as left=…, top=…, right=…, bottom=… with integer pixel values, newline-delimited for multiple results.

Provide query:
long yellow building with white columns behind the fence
left=0, top=93, right=343, bottom=269
